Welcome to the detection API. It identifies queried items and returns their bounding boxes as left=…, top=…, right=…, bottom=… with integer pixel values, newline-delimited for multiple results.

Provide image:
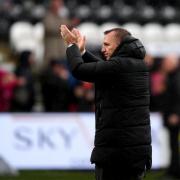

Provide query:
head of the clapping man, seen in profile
left=101, top=28, right=131, bottom=60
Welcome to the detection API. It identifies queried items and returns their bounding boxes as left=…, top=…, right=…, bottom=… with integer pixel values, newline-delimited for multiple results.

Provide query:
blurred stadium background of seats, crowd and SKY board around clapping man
left=0, top=0, right=180, bottom=180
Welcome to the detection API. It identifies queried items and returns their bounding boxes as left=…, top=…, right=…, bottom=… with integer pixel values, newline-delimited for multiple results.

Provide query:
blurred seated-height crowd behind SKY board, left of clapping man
left=0, top=51, right=94, bottom=112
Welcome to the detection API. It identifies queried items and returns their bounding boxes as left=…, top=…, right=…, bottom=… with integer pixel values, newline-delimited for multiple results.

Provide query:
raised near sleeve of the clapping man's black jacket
left=66, top=45, right=117, bottom=82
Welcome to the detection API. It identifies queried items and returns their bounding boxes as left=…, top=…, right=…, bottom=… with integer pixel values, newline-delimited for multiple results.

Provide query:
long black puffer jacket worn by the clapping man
left=67, top=36, right=151, bottom=172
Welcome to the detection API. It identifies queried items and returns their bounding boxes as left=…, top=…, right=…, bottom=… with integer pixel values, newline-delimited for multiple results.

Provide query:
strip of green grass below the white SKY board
left=0, top=170, right=167, bottom=180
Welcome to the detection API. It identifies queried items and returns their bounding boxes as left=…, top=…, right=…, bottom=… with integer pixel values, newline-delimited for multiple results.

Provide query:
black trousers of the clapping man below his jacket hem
left=95, top=165, right=144, bottom=180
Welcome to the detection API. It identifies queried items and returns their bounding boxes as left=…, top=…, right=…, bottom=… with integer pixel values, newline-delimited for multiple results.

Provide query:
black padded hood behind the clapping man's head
left=113, top=35, right=146, bottom=59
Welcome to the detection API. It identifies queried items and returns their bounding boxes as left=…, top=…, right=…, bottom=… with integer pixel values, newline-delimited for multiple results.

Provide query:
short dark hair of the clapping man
left=104, top=28, right=131, bottom=42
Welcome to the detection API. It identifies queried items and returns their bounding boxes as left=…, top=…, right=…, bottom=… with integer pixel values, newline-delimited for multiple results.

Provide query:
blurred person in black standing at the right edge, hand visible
left=162, top=55, right=180, bottom=179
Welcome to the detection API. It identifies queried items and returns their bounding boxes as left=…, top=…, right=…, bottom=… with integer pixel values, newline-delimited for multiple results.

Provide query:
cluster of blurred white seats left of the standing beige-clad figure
left=10, top=22, right=45, bottom=62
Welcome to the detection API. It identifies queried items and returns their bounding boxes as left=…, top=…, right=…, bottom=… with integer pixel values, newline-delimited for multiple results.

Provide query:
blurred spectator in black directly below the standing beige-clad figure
left=41, top=60, right=71, bottom=112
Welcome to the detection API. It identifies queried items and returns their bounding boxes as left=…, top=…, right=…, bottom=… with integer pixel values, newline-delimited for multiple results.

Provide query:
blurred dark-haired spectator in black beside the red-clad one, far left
left=11, top=51, right=35, bottom=112
